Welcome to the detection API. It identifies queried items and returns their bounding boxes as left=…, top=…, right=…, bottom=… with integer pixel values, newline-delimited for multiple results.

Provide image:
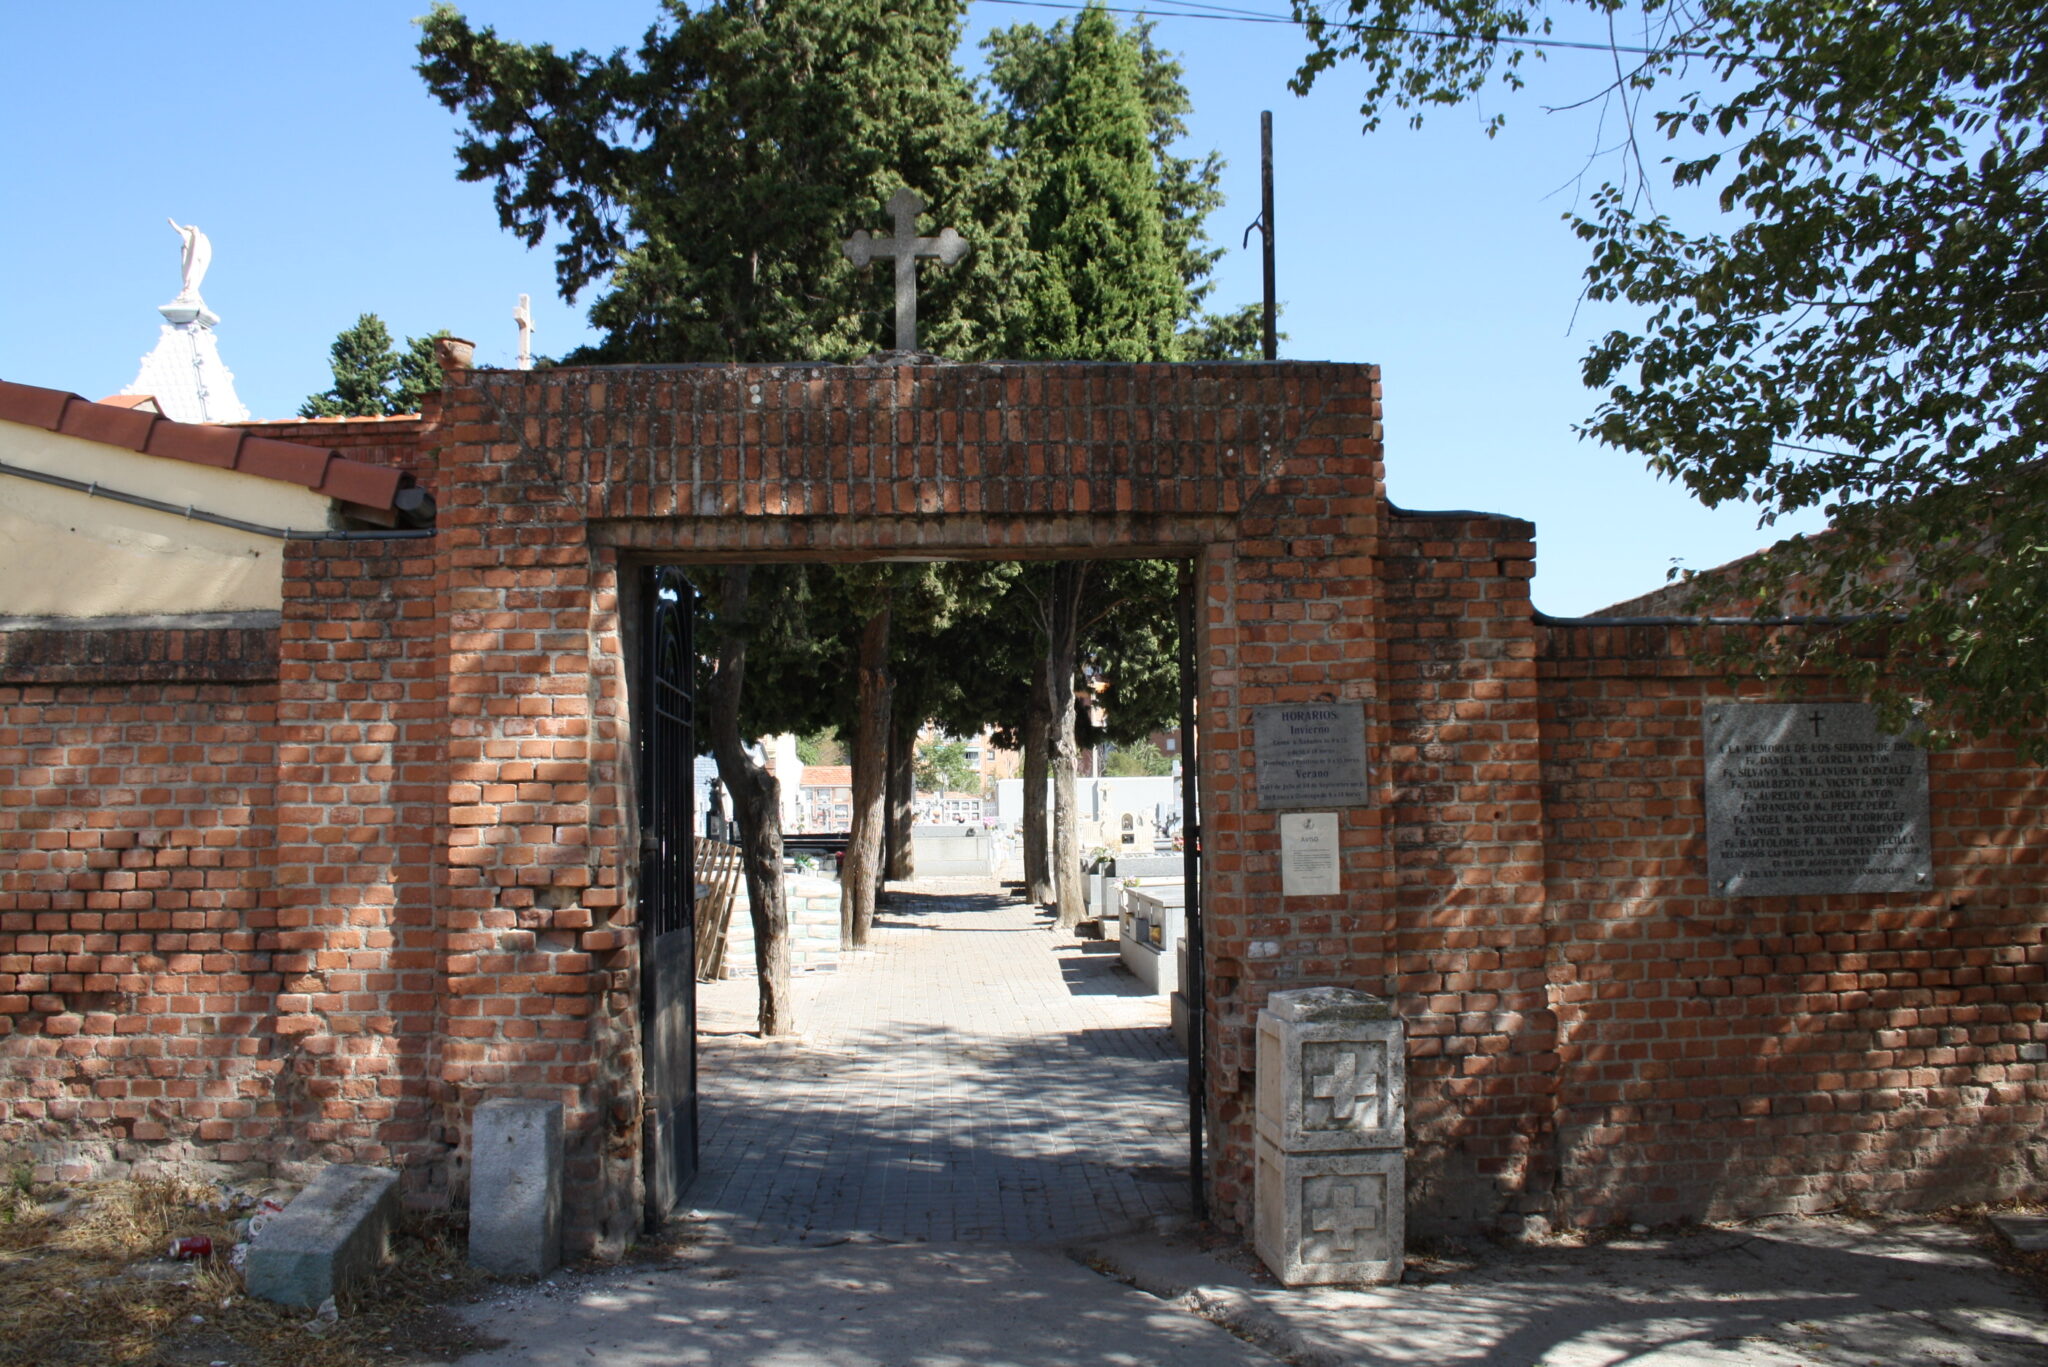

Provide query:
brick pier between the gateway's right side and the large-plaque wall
left=1384, top=512, right=1556, bottom=1228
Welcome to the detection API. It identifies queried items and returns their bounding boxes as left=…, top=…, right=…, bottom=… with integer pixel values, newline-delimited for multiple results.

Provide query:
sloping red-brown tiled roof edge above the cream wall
left=0, top=379, right=414, bottom=508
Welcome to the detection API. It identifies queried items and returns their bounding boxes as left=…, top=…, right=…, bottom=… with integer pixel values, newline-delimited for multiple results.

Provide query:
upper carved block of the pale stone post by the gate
left=1255, top=988, right=1407, bottom=1154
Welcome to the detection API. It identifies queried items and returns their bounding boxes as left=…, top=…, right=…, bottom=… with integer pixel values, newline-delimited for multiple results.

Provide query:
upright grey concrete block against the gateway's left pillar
left=469, top=1096, right=561, bottom=1277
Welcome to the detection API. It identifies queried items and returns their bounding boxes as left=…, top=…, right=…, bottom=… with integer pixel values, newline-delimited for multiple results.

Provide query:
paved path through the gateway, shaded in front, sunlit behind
left=684, top=879, right=1188, bottom=1244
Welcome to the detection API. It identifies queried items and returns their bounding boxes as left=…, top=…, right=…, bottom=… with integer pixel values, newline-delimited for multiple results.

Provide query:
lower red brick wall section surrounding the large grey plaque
left=1538, top=623, right=2048, bottom=1224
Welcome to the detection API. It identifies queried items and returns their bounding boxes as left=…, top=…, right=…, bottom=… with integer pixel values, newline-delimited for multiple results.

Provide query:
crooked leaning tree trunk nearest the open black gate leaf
left=711, top=566, right=797, bottom=1037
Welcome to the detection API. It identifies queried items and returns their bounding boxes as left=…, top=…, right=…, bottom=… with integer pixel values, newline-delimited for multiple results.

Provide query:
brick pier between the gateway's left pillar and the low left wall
left=264, top=539, right=453, bottom=1201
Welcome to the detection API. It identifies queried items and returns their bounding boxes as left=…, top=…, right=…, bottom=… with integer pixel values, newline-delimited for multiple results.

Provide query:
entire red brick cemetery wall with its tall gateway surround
left=0, top=363, right=2048, bottom=1254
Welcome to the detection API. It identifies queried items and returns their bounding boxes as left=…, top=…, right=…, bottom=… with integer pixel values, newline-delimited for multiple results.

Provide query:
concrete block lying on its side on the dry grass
left=242, top=1164, right=397, bottom=1306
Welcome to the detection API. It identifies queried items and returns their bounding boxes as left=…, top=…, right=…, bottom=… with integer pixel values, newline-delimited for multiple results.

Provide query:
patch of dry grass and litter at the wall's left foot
left=0, top=1170, right=495, bottom=1367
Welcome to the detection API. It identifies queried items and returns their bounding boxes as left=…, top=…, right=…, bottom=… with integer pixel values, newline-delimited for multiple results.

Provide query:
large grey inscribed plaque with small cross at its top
left=1706, top=703, right=1933, bottom=898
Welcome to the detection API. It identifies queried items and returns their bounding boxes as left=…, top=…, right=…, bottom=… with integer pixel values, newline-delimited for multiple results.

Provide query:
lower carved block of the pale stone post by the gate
left=1251, top=1135, right=1407, bottom=1287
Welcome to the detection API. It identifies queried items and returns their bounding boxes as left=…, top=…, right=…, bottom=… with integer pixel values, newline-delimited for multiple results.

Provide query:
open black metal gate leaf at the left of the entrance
left=639, top=566, right=696, bottom=1230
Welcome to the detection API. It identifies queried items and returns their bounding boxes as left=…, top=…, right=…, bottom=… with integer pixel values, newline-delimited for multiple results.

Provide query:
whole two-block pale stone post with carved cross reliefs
left=1251, top=988, right=1407, bottom=1287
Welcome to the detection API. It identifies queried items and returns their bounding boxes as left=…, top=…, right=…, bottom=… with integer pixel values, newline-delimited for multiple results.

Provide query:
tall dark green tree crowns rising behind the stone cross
left=420, top=0, right=1223, bottom=363
